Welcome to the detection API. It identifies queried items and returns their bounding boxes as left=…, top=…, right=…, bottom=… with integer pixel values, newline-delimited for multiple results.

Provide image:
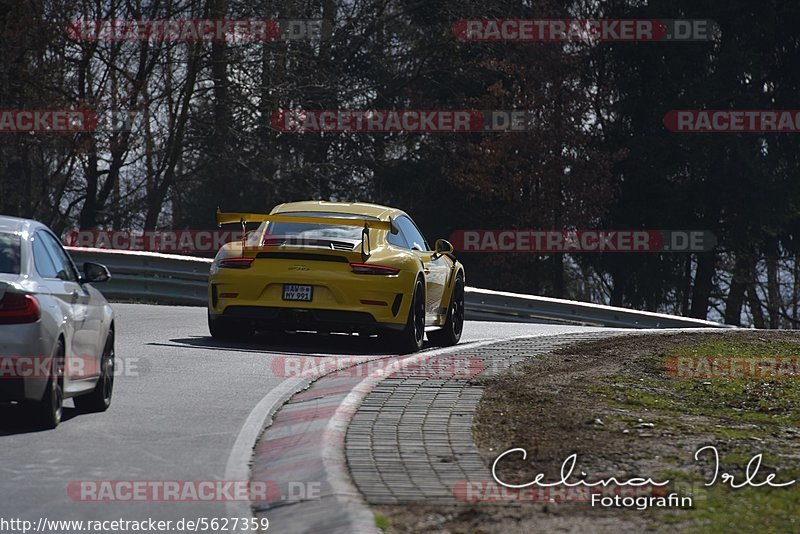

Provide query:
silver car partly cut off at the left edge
left=0, top=215, right=114, bottom=428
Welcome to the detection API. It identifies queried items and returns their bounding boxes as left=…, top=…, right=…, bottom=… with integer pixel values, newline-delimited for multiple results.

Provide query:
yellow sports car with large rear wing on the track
left=208, top=201, right=465, bottom=353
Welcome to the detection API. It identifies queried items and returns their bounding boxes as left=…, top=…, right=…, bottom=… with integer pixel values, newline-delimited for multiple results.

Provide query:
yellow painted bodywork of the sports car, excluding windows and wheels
left=208, top=201, right=464, bottom=331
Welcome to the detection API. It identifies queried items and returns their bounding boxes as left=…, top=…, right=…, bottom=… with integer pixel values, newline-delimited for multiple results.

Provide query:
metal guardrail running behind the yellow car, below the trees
left=67, top=247, right=732, bottom=328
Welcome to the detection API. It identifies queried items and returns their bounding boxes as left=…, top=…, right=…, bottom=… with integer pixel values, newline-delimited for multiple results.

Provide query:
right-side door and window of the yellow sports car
left=396, top=216, right=450, bottom=325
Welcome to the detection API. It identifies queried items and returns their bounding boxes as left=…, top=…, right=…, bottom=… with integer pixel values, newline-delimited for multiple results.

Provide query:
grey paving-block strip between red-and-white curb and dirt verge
left=346, top=330, right=641, bottom=504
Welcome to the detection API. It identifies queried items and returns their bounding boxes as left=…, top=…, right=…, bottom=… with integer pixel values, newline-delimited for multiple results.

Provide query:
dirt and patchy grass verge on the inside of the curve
left=374, top=331, right=800, bottom=533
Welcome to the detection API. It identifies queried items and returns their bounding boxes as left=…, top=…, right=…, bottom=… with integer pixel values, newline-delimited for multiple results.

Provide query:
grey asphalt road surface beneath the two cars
left=0, top=304, right=608, bottom=522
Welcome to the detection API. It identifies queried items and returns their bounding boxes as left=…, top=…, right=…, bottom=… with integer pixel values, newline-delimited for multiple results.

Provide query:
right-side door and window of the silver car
left=37, top=230, right=97, bottom=380
